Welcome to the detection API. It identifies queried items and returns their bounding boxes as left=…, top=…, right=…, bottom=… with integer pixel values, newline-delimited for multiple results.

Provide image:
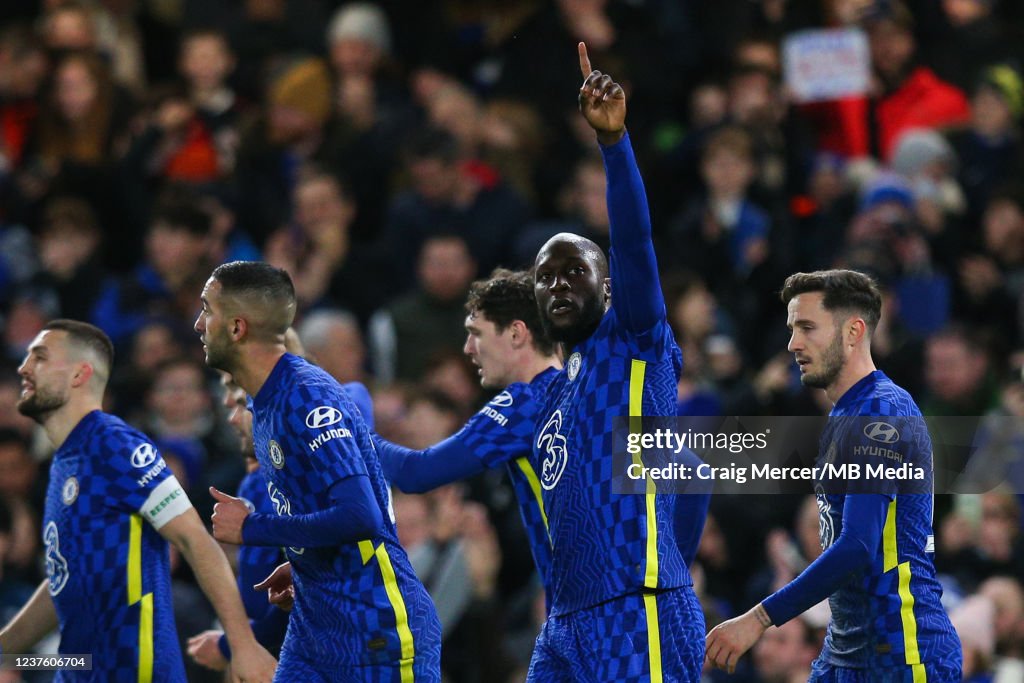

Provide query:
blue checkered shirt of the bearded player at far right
left=818, top=372, right=961, bottom=680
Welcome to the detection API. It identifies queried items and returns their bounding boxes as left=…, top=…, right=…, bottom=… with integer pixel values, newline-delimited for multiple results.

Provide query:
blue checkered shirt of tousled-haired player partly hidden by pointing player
left=455, top=368, right=558, bottom=587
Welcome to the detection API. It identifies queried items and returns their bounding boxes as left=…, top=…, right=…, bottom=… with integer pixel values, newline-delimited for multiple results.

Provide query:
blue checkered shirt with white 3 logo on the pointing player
left=534, top=308, right=691, bottom=614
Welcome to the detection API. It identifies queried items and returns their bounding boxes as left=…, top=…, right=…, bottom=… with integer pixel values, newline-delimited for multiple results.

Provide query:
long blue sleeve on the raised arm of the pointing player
left=601, top=135, right=665, bottom=332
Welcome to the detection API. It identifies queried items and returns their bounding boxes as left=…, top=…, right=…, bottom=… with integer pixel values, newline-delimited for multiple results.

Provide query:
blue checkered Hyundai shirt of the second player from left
left=253, top=354, right=440, bottom=680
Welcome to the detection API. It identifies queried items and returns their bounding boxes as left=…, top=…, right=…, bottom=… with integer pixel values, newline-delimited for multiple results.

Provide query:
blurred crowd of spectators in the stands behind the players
left=0, top=0, right=1024, bottom=683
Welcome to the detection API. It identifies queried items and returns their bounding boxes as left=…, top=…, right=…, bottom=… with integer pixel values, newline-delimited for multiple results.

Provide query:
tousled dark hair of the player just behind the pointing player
left=466, top=268, right=555, bottom=355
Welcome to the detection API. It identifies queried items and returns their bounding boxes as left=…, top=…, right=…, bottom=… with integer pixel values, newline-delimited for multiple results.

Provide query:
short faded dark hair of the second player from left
left=211, top=261, right=295, bottom=335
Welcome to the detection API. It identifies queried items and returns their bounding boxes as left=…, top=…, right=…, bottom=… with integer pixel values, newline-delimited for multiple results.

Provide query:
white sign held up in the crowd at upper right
left=782, top=29, right=871, bottom=103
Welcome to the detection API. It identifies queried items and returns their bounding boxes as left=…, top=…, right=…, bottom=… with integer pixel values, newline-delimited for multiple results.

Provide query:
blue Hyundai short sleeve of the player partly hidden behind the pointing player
left=454, top=382, right=540, bottom=468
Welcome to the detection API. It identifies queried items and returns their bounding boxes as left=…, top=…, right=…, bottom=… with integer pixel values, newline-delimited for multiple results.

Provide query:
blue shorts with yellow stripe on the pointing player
left=526, top=587, right=705, bottom=683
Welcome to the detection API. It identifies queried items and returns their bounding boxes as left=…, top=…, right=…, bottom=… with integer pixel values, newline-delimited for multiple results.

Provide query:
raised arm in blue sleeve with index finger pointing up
left=579, top=43, right=666, bottom=333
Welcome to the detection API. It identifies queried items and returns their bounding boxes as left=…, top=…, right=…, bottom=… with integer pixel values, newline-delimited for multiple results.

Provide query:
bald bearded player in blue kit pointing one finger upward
left=528, top=43, right=703, bottom=683
